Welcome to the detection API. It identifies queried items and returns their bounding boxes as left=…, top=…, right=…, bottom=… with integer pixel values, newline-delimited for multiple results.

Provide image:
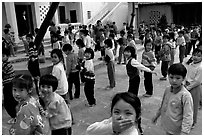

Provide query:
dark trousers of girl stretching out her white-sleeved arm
left=128, top=75, right=140, bottom=96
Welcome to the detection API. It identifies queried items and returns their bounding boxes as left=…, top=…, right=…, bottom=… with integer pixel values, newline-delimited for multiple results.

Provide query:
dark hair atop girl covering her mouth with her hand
left=111, top=92, right=141, bottom=120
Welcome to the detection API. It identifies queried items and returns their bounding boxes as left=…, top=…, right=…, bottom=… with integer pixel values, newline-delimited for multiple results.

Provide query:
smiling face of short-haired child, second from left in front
left=39, top=85, right=53, bottom=99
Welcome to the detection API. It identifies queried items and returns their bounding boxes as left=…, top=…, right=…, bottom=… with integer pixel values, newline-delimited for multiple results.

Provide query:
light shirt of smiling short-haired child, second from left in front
left=45, top=92, right=72, bottom=130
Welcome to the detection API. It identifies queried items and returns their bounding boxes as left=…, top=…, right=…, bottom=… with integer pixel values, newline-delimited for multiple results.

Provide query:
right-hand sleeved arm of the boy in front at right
left=181, top=92, right=193, bottom=134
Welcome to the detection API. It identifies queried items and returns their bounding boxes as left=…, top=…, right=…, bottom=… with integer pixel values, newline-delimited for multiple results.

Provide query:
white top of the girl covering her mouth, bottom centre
left=86, top=117, right=138, bottom=135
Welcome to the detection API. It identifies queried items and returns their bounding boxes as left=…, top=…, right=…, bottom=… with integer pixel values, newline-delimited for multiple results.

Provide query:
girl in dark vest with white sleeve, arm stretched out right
left=124, top=46, right=156, bottom=96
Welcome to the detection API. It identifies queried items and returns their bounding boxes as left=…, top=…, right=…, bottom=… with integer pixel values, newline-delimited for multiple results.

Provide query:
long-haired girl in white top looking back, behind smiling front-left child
left=51, top=49, right=69, bottom=104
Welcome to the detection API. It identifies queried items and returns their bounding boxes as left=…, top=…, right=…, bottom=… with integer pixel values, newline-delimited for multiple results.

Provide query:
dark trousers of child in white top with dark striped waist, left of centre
left=84, top=79, right=96, bottom=105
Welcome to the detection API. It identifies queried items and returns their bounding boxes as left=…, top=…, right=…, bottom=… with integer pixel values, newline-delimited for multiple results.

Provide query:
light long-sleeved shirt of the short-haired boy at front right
left=160, top=85, right=193, bottom=134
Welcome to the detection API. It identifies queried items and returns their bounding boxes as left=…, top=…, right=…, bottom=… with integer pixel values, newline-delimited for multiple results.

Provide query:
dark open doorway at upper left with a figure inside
left=15, top=4, right=34, bottom=36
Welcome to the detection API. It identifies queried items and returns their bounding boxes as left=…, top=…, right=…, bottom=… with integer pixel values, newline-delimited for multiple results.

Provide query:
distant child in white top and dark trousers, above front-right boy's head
left=176, top=30, right=186, bottom=63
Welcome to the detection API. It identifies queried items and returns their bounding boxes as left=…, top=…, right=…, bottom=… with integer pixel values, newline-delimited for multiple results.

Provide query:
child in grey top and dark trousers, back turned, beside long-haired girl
left=62, top=44, right=80, bottom=100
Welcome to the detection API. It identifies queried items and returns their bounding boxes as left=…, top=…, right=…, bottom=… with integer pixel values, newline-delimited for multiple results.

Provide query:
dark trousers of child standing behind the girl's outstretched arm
left=144, top=72, right=153, bottom=95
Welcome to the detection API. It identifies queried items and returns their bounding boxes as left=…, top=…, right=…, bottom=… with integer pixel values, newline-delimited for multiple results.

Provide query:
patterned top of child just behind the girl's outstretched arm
left=142, top=51, right=156, bottom=67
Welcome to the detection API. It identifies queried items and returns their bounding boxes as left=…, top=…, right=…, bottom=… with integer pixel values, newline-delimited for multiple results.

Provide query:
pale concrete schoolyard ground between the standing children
left=2, top=41, right=202, bottom=135
